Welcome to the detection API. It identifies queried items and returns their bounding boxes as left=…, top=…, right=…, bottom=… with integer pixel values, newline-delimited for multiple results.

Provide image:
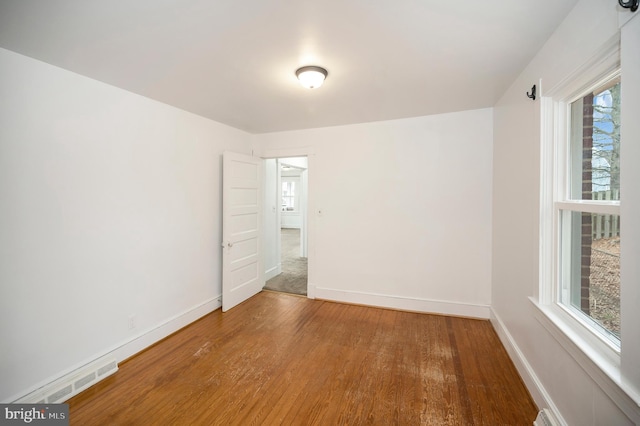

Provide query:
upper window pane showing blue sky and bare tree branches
left=569, top=79, right=620, bottom=200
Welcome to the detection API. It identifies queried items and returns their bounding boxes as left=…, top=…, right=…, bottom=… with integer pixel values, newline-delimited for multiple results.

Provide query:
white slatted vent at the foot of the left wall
left=15, top=357, right=118, bottom=404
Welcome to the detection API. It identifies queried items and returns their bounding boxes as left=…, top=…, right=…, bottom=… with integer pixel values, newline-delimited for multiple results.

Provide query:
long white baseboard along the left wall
left=5, top=295, right=222, bottom=403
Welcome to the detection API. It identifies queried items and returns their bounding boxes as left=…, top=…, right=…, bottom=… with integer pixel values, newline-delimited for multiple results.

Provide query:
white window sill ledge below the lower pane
left=529, top=297, right=640, bottom=413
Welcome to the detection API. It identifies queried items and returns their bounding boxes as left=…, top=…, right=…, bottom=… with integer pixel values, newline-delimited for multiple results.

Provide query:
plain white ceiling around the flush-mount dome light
left=0, top=0, right=577, bottom=133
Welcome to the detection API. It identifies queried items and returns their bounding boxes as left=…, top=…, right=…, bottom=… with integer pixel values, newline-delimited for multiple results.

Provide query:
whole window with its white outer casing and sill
left=531, top=19, right=640, bottom=412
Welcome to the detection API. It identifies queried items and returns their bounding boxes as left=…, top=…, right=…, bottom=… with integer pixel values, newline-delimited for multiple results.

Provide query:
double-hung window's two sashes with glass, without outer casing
left=555, top=77, right=620, bottom=347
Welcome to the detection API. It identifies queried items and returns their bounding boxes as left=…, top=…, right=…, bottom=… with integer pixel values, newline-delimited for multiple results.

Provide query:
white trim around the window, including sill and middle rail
left=530, top=37, right=640, bottom=406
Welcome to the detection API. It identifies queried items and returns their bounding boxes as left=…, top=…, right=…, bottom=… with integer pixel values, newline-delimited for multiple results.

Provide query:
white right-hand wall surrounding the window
left=492, top=0, right=640, bottom=425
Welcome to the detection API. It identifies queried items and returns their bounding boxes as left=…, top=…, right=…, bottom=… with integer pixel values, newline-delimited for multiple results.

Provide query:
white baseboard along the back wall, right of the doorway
left=313, top=287, right=490, bottom=319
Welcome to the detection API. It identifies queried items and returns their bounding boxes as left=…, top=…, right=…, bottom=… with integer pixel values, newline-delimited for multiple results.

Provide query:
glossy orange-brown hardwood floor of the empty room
left=68, top=292, right=537, bottom=425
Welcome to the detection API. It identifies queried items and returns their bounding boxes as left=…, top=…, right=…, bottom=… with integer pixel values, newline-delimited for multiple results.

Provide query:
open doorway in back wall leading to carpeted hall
left=264, top=157, right=308, bottom=296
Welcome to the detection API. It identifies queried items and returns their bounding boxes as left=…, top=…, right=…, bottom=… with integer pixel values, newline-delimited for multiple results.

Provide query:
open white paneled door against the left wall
left=222, top=152, right=264, bottom=312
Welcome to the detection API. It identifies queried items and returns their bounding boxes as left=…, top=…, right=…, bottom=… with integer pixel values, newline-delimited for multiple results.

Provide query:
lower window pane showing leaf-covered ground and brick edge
left=560, top=211, right=620, bottom=344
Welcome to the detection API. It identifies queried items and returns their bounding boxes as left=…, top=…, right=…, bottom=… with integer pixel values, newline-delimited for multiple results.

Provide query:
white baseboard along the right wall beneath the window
left=490, top=308, right=567, bottom=426
